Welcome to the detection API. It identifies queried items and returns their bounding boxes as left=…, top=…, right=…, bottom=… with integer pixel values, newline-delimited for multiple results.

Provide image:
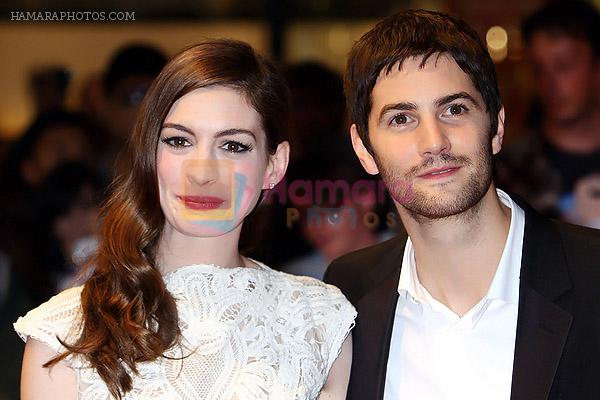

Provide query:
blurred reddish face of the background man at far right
left=528, top=32, right=600, bottom=123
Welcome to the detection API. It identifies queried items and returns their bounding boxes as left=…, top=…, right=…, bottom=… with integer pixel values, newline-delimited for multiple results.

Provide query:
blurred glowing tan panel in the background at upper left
left=0, top=20, right=269, bottom=141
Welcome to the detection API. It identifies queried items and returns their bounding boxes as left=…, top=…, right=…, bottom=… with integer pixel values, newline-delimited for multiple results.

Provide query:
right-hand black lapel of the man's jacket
left=511, top=204, right=572, bottom=400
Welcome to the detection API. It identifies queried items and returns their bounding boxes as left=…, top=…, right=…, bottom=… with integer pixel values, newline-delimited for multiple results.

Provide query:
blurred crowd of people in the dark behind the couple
left=0, top=2, right=600, bottom=399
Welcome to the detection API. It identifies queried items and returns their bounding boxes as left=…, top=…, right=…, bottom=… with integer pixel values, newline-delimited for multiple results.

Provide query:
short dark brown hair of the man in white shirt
left=344, top=10, right=502, bottom=150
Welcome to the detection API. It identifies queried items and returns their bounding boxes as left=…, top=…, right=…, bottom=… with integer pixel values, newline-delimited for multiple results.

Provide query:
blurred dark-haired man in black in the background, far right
left=498, top=1, right=600, bottom=223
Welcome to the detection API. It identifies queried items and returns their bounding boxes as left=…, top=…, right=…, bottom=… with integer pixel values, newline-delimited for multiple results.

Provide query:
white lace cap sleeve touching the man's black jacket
left=325, top=285, right=357, bottom=373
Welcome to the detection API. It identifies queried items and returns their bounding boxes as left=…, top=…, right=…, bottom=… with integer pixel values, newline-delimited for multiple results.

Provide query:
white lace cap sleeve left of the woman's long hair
left=13, top=286, right=83, bottom=353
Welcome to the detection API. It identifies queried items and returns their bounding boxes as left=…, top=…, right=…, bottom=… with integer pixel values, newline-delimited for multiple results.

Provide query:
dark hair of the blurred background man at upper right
left=521, top=0, right=600, bottom=57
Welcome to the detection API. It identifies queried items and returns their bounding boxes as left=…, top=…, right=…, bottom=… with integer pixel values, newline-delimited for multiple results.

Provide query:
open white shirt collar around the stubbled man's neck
left=398, top=189, right=525, bottom=308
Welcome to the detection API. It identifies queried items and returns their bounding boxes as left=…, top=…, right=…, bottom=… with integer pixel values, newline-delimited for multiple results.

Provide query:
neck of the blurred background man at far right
left=542, top=107, right=600, bottom=155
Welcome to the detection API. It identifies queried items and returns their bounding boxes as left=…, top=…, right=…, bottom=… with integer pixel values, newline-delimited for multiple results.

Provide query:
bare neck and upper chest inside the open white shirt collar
left=398, top=184, right=510, bottom=316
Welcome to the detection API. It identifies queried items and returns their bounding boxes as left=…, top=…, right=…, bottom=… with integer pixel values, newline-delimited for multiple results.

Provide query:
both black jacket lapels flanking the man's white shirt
left=349, top=196, right=572, bottom=400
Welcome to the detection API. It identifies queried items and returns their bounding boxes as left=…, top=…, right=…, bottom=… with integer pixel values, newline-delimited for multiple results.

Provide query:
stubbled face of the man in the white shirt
left=352, top=55, right=503, bottom=219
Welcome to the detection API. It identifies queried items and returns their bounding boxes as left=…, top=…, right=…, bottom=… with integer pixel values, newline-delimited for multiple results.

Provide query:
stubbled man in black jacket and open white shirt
left=325, top=11, right=600, bottom=400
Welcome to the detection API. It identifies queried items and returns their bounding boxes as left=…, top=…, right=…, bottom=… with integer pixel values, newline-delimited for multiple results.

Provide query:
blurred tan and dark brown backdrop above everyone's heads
left=0, top=0, right=600, bottom=141
